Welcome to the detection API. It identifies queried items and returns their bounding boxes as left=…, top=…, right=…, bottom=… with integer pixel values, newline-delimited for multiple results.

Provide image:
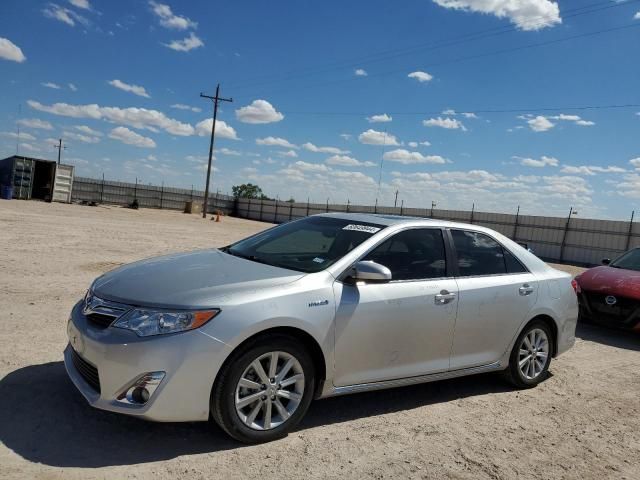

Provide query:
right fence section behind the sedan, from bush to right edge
left=235, top=198, right=640, bottom=265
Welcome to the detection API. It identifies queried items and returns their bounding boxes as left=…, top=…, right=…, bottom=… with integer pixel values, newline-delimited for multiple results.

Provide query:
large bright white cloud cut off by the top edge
left=433, top=0, right=562, bottom=30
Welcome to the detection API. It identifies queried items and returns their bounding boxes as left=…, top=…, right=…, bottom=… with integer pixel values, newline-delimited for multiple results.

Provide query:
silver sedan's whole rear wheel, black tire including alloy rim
left=505, top=320, right=554, bottom=388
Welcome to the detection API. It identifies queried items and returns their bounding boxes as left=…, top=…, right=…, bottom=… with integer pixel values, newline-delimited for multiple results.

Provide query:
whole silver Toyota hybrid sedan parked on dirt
left=65, top=214, right=578, bottom=443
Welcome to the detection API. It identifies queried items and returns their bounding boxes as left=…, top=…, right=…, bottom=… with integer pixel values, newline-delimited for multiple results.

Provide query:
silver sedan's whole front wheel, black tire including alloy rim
left=211, top=334, right=315, bottom=444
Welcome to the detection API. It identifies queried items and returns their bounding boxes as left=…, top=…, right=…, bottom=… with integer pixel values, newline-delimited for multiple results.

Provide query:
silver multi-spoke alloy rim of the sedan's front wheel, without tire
left=235, top=351, right=305, bottom=430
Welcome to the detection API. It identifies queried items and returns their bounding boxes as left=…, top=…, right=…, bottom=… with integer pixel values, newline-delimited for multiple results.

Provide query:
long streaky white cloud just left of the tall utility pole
left=27, top=100, right=195, bottom=136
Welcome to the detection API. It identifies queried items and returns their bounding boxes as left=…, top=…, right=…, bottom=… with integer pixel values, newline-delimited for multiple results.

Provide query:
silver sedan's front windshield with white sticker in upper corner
left=222, top=217, right=384, bottom=273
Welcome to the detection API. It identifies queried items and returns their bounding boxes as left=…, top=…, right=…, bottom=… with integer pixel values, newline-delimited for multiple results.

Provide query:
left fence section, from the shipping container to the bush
left=72, top=177, right=234, bottom=215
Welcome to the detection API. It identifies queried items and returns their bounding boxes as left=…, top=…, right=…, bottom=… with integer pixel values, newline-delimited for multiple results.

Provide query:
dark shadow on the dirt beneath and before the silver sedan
left=0, top=362, right=511, bottom=468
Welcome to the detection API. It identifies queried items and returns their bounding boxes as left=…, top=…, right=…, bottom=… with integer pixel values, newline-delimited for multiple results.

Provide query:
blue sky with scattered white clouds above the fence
left=0, top=0, right=640, bottom=219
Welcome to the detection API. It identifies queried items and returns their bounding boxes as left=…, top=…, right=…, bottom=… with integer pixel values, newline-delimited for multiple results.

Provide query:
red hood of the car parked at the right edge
left=576, top=266, right=640, bottom=300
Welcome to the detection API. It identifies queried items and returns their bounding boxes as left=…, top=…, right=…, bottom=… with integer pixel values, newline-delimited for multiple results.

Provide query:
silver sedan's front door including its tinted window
left=334, top=228, right=458, bottom=386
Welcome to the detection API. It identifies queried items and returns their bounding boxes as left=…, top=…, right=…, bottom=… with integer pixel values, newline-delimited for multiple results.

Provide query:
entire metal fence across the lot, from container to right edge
left=72, top=177, right=640, bottom=265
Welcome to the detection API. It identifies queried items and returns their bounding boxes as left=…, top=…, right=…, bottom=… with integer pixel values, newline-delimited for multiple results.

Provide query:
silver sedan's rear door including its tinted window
left=450, top=229, right=538, bottom=369
